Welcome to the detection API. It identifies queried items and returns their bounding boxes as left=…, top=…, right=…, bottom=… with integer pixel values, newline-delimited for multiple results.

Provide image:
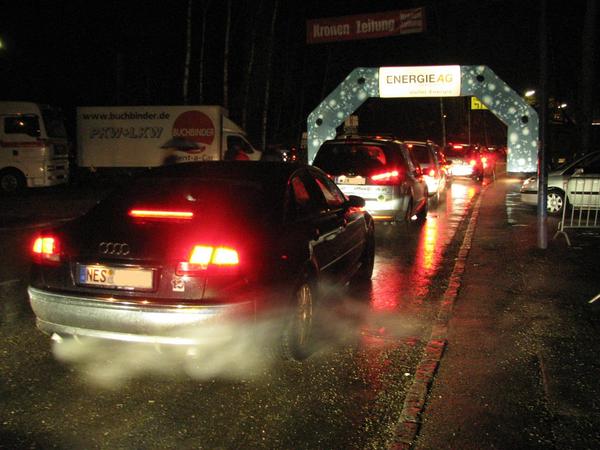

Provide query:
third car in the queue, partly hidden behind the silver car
left=404, top=141, right=449, bottom=200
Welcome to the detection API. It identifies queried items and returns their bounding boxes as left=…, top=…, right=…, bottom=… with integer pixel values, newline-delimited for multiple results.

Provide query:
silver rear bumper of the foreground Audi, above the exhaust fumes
left=27, top=286, right=254, bottom=345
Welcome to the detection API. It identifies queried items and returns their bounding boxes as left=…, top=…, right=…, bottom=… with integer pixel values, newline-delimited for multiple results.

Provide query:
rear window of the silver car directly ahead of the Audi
left=313, top=143, right=398, bottom=176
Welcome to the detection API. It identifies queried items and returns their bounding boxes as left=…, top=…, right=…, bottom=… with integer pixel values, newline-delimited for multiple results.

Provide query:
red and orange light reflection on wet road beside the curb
left=362, top=179, right=487, bottom=339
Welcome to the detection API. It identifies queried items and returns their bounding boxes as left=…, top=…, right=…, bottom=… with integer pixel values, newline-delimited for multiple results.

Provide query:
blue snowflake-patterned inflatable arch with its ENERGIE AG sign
left=307, top=66, right=539, bottom=173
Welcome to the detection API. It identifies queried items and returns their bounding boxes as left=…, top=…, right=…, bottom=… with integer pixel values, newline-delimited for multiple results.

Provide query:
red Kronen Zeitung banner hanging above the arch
left=306, top=8, right=425, bottom=44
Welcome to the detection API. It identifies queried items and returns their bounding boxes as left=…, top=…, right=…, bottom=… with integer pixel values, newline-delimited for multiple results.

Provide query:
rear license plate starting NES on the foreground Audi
left=77, top=265, right=154, bottom=290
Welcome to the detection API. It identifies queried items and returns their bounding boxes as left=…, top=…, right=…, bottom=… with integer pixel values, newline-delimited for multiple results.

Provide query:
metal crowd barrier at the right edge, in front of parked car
left=554, top=175, right=600, bottom=247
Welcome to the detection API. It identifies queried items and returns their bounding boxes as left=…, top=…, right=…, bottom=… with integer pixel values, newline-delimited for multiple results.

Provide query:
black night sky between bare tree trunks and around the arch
left=0, top=0, right=599, bottom=148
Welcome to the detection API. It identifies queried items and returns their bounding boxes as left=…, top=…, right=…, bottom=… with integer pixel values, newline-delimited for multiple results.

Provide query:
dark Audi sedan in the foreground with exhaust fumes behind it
left=28, top=161, right=375, bottom=359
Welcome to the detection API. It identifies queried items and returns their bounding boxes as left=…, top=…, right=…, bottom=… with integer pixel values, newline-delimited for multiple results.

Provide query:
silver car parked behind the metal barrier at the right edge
left=521, top=151, right=600, bottom=215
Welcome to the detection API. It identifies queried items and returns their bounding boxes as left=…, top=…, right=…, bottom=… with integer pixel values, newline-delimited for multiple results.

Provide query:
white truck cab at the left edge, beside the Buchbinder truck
left=0, top=101, right=69, bottom=193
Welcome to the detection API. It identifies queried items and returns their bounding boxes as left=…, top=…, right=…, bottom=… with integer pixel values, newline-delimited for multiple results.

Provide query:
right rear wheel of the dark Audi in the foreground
left=281, top=275, right=317, bottom=361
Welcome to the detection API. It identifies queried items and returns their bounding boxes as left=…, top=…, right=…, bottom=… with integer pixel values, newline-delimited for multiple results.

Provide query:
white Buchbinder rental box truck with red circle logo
left=77, top=105, right=260, bottom=169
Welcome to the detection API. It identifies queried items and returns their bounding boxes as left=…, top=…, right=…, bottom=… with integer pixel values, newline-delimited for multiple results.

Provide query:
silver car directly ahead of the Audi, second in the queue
left=313, top=137, right=428, bottom=222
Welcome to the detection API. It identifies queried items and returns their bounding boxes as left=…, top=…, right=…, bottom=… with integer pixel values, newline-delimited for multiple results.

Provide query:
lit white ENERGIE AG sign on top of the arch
left=379, top=66, right=460, bottom=98
